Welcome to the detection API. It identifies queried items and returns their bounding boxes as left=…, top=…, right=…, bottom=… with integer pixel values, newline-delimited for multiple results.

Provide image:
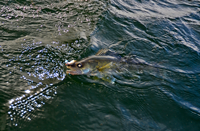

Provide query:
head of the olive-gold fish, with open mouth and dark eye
left=65, top=60, right=92, bottom=75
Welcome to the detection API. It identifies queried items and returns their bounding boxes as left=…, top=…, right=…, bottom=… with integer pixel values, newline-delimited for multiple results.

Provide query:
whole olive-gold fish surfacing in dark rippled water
left=65, top=49, right=152, bottom=76
